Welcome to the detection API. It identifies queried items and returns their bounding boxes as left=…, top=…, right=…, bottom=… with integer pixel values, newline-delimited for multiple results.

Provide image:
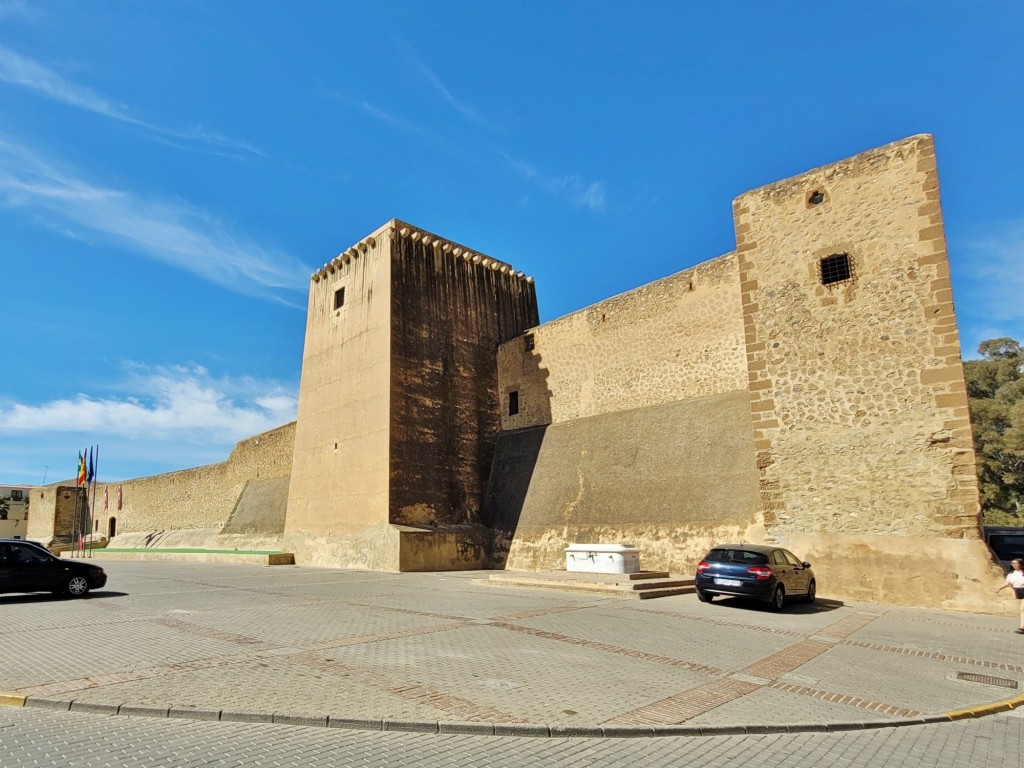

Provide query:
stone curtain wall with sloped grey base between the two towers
left=485, top=254, right=757, bottom=571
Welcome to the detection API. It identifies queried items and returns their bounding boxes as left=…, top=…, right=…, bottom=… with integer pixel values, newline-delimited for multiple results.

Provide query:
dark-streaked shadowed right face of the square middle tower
left=389, top=226, right=538, bottom=525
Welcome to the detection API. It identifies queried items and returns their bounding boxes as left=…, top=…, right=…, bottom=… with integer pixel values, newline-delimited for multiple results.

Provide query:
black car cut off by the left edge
left=0, top=539, right=106, bottom=597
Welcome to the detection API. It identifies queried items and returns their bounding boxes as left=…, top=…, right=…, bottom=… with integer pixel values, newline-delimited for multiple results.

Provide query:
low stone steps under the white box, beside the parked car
left=479, top=570, right=696, bottom=600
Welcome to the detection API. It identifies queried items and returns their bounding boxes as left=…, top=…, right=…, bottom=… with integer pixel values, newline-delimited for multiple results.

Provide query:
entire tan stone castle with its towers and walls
left=29, top=135, right=998, bottom=609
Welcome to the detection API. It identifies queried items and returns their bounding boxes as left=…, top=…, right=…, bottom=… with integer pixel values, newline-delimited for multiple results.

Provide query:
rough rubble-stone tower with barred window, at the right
left=734, top=136, right=989, bottom=604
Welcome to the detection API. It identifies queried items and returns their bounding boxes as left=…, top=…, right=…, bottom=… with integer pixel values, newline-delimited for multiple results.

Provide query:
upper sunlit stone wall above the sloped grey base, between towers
left=499, top=254, right=746, bottom=430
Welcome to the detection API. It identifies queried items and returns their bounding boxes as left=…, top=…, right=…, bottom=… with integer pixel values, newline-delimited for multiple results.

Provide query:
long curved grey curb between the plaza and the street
left=0, top=691, right=1007, bottom=738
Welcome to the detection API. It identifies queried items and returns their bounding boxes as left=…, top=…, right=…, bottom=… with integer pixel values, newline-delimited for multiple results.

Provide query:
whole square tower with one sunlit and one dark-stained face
left=285, top=220, right=538, bottom=571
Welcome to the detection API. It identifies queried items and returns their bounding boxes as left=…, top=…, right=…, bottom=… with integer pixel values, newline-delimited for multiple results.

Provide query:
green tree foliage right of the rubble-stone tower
left=964, top=338, right=1024, bottom=525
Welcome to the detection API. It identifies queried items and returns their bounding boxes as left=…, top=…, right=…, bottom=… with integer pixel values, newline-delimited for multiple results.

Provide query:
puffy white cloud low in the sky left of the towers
left=0, top=364, right=297, bottom=447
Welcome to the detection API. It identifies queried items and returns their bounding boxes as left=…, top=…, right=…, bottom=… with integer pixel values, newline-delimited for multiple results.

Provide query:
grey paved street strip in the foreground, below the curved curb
left=0, top=708, right=1024, bottom=768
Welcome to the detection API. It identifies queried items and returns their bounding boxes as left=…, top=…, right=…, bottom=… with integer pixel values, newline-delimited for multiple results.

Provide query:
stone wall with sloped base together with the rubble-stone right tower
left=486, top=135, right=997, bottom=607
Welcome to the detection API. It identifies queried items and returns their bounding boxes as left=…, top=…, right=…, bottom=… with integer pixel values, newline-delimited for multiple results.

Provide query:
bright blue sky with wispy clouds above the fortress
left=0, top=0, right=1024, bottom=483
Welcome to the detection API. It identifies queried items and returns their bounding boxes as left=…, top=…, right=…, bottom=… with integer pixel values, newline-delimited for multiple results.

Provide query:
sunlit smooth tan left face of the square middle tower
left=286, top=226, right=391, bottom=544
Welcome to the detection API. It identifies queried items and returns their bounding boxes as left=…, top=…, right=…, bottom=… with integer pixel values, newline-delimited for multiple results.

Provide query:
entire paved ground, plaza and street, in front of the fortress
left=0, top=560, right=1024, bottom=766
